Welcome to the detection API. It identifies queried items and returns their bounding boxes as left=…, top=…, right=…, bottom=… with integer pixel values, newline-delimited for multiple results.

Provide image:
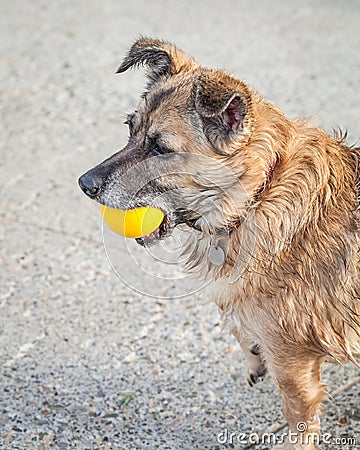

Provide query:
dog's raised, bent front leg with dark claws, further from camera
left=231, top=326, right=266, bottom=386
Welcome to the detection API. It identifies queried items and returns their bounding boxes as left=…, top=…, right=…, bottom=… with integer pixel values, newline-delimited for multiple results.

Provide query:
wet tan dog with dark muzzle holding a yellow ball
left=79, top=38, right=360, bottom=450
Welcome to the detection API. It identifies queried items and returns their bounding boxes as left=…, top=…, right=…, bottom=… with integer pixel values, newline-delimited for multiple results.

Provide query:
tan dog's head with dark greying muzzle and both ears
left=79, top=39, right=274, bottom=245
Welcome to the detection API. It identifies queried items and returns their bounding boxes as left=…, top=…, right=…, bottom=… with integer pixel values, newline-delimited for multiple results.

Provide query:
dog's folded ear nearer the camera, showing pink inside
left=195, top=72, right=254, bottom=150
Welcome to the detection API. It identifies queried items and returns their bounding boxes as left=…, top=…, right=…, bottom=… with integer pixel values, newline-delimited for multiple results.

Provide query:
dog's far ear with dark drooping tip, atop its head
left=116, top=38, right=196, bottom=81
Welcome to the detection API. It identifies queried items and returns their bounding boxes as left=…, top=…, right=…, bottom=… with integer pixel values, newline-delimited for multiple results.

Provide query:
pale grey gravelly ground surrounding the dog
left=0, top=0, right=360, bottom=450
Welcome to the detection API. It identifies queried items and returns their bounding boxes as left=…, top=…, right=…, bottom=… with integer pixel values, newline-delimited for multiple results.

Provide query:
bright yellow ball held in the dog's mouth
left=100, top=205, right=164, bottom=238
